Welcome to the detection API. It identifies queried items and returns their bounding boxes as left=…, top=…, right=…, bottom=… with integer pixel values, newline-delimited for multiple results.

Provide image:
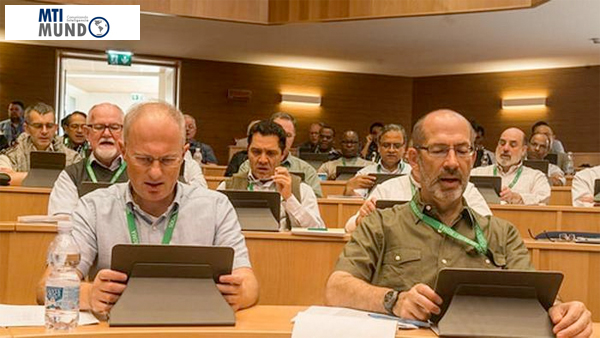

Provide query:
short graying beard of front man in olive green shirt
left=417, top=157, right=467, bottom=201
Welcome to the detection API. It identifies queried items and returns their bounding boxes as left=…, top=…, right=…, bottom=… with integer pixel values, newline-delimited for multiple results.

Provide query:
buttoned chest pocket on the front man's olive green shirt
left=379, top=248, right=422, bottom=290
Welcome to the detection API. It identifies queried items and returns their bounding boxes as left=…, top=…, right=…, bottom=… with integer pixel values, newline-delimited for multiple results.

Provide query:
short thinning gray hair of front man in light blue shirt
left=123, top=101, right=186, bottom=144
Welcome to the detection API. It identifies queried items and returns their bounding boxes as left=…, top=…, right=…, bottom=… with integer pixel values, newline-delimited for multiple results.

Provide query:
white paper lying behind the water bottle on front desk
left=0, top=304, right=99, bottom=326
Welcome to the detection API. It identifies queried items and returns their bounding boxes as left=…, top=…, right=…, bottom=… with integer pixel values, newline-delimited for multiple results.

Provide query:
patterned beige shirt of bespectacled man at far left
left=0, top=134, right=82, bottom=172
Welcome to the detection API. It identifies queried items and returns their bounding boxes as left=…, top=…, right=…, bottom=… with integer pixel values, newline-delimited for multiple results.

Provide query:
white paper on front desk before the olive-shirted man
left=292, top=312, right=397, bottom=338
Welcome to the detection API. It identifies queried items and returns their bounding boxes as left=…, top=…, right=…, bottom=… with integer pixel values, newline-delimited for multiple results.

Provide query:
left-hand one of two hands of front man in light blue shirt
left=88, top=269, right=127, bottom=315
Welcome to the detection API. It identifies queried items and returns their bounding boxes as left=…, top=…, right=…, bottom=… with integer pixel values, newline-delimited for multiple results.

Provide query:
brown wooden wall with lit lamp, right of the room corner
left=413, top=66, right=600, bottom=152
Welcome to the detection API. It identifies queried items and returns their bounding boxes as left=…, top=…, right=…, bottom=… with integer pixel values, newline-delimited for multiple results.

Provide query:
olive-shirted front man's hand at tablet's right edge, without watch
left=548, top=302, right=592, bottom=338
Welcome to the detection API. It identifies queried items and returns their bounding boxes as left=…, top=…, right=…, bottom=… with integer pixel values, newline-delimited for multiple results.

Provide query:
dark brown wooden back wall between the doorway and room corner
left=180, top=60, right=412, bottom=163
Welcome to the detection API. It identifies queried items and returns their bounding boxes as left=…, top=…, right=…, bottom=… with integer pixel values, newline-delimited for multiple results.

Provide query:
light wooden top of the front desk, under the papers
left=0, top=306, right=436, bottom=338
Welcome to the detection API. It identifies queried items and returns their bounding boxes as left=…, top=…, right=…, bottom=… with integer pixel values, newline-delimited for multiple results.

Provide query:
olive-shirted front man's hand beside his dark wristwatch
left=394, top=283, right=442, bottom=321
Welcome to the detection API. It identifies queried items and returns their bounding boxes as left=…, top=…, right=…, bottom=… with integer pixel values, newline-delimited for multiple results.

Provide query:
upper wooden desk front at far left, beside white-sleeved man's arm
left=0, top=186, right=51, bottom=222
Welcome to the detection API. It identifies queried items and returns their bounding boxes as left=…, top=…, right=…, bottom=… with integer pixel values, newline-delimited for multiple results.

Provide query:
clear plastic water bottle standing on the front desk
left=45, top=222, right=81, bottom=331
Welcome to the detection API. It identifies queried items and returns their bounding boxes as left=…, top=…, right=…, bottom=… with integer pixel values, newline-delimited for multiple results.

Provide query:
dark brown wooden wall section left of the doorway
left=0, top=43, right=56, bottom=120
